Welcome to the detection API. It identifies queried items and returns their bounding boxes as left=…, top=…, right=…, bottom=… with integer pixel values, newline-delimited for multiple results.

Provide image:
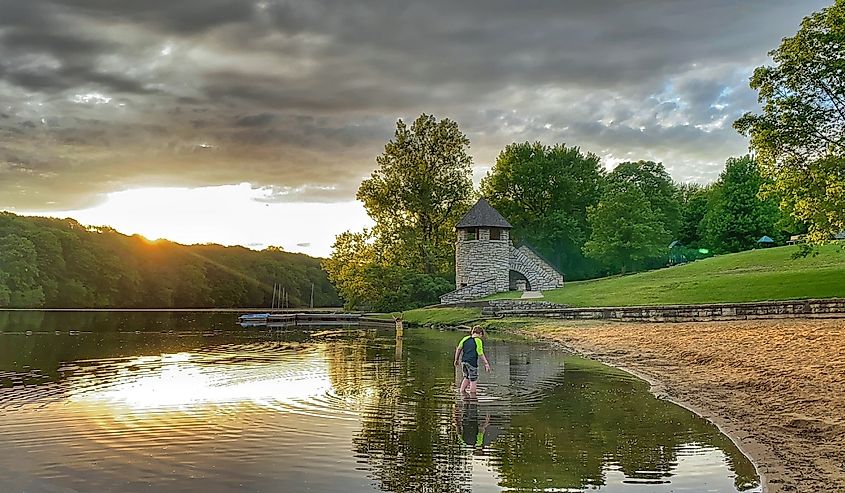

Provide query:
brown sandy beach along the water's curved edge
left=527, top=319, right=845, bottom=493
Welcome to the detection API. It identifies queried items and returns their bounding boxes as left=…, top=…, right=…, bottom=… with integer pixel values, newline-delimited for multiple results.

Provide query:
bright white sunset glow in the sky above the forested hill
left=22, top=183, right=372, bottom=257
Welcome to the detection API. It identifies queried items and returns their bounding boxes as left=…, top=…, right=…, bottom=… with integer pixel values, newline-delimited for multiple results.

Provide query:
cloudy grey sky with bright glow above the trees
left=0, top=0, right=832, bottom=256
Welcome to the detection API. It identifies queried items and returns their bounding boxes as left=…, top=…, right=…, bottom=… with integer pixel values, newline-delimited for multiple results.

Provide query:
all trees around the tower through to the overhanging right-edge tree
left=323, top=0, right=845, bottom=311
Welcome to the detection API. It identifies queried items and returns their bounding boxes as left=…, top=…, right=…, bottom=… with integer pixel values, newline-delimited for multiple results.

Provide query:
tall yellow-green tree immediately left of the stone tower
left=357, top=114, right=472, bottom=274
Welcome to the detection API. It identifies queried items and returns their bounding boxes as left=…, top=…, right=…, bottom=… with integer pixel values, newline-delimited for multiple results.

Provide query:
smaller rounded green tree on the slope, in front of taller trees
left=584, top=181, right=671, bottom=272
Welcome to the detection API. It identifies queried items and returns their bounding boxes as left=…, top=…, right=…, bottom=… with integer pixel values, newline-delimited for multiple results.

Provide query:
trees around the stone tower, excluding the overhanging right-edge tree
left=324, top=119, right=788, bottom=311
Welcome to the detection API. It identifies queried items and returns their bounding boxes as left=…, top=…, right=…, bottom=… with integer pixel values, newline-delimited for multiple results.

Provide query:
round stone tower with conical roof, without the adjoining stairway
left=455, top=198, right=512, bottom=296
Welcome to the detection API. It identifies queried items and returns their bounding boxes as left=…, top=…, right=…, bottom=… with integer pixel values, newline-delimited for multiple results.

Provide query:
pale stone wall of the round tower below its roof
left=455, top=228, right=511, bottom=296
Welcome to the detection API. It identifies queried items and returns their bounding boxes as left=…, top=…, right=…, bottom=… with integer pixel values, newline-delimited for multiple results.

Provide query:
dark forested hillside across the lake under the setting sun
left=0, top=212, right=340, bottom=308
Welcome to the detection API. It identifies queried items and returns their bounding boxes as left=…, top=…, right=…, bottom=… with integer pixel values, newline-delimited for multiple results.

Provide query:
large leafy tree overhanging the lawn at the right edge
left=734, top=0, right=845, bottom=241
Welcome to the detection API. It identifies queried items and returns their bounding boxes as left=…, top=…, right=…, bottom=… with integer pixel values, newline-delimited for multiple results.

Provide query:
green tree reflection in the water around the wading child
left=328, top=330, right=758, bottom=492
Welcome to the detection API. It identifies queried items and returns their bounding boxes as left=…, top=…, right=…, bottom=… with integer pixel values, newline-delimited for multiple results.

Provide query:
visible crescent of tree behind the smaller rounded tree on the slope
left=608, top=161, right=681, bottom=236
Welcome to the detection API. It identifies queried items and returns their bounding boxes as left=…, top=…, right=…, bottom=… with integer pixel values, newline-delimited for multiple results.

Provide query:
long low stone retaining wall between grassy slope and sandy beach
left=494, top=298, right=845, bottom=322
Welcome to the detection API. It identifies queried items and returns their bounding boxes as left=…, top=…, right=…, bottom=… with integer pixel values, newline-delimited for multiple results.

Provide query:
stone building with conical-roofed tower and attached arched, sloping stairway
left=440, top=198, right=563, bottom=303
